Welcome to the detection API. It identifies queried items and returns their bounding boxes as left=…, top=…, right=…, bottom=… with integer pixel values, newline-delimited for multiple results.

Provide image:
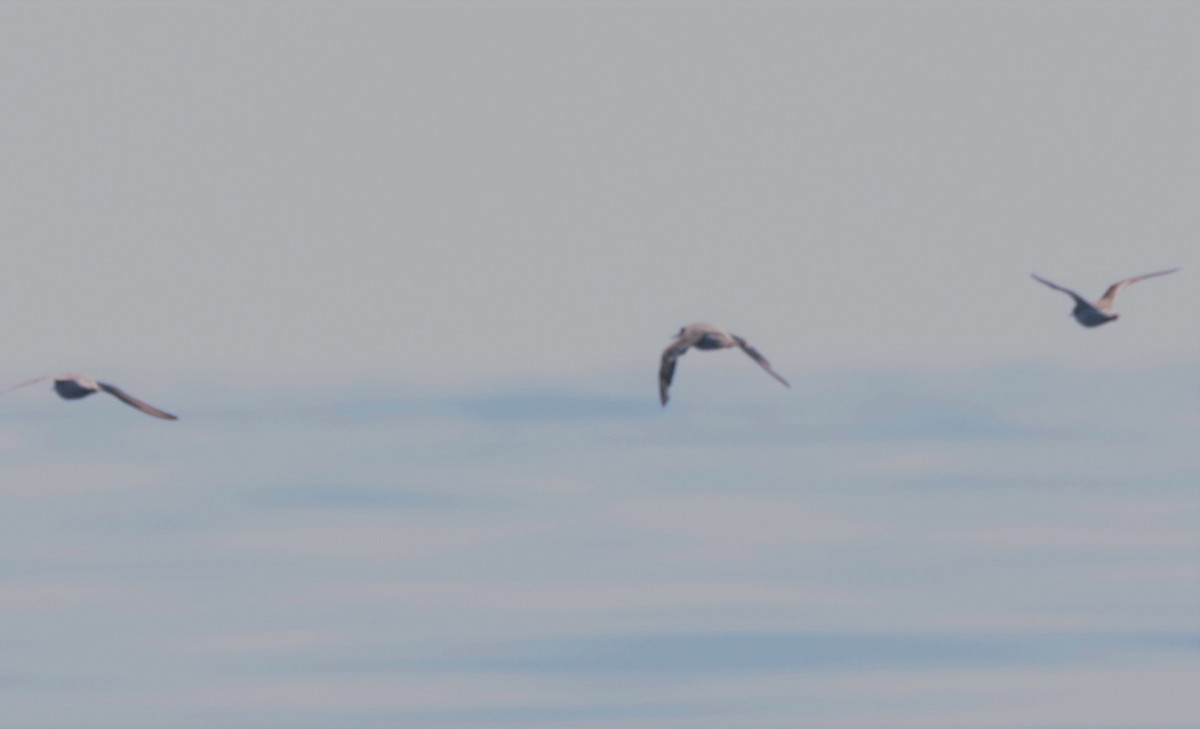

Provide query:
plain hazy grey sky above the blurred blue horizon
left=0, top=1, right=1200, bottom=384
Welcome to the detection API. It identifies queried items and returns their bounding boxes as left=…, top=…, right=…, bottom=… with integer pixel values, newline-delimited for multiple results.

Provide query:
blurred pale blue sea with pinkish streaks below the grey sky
left=0, top=364, right=1200, bottom=729
